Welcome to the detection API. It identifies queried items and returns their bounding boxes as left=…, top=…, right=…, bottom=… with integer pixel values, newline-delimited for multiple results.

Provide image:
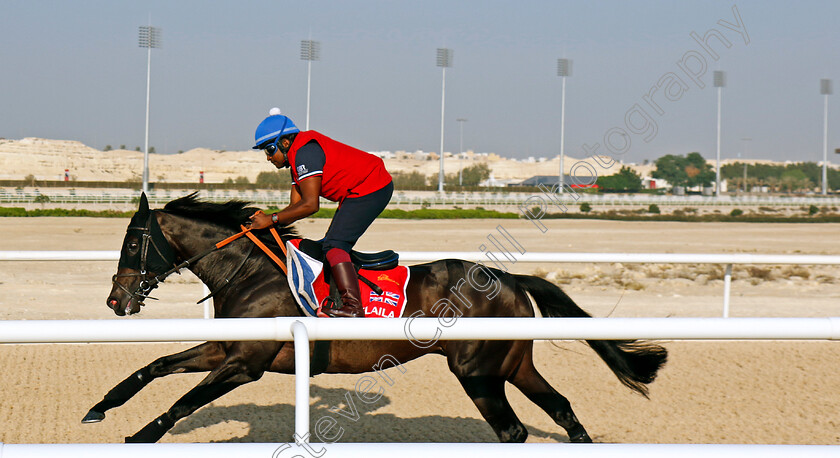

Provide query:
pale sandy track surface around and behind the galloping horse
left=0, top=218, right=840, bottom=444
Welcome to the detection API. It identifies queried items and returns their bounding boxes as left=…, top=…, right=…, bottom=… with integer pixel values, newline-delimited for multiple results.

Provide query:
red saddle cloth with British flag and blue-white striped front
left=286, top=239, right=409, bottom=318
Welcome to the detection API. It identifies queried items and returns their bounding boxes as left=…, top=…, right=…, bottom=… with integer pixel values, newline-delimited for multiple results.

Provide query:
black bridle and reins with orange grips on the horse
left=111, top=214, right=289, bottom=305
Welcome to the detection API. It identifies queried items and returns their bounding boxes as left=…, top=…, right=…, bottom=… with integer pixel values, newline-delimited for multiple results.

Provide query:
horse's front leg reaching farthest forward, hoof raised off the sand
left=82, top=342, right=225, bottom=423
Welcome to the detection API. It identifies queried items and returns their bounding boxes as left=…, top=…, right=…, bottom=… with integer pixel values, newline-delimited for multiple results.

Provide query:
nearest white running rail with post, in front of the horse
left=0, top=317, right=840, bottom=458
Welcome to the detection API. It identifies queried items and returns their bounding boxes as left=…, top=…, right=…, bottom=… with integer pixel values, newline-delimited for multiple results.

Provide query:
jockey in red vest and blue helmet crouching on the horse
left=250, top=108, right=394, bottom=317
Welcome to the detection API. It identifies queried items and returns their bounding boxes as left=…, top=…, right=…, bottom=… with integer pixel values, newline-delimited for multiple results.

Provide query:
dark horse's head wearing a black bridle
left=106, top=193, right=175, bottom=316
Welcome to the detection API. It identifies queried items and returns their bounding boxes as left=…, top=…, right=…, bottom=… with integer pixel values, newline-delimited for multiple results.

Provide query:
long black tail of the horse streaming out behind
left=514, top=275, right=668, bottom=397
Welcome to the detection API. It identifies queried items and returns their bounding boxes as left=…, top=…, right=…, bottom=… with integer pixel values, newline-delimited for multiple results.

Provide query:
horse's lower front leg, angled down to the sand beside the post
left=125, top=342, right=285, bottom=443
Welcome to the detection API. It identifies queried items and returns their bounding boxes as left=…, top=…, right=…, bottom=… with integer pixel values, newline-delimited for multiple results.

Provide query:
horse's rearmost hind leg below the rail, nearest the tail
left=510, top=349, right=592, bottom=442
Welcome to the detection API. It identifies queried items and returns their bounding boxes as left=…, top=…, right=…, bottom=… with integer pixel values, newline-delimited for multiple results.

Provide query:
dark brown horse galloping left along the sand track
left=82, top=193, right=667, bottom=443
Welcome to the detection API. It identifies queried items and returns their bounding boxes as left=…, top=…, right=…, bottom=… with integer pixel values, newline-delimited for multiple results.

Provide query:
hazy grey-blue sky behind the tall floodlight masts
left=0, top=0, right=840, bottom=163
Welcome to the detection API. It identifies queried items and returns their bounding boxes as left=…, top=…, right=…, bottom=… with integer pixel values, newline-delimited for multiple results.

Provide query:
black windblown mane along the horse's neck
left=163, top=192, right=297, bottom=236
